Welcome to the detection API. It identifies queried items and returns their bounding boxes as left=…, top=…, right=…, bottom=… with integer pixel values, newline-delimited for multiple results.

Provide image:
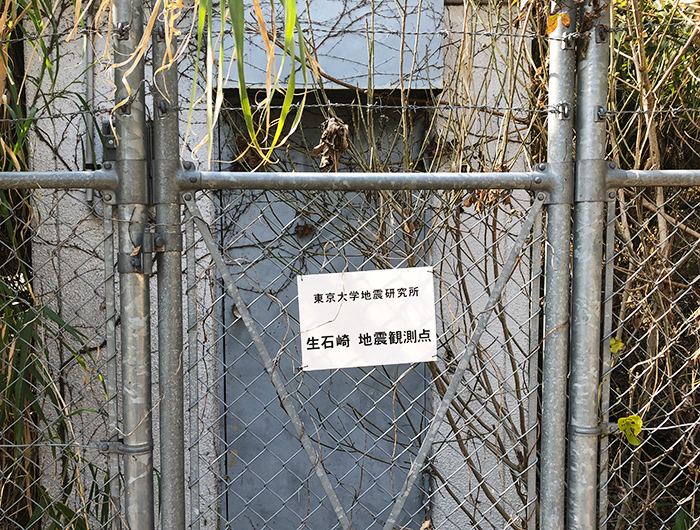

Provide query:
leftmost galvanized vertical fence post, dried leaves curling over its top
left=112, top=0, right=154, bottom=530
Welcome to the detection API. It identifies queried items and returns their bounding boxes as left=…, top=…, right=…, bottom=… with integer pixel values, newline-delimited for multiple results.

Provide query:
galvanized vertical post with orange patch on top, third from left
left=540, top=0, right=576, bottom=530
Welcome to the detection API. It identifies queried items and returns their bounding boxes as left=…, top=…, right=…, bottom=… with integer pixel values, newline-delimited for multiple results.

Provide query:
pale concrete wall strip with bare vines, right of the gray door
left=433, top=3, right=539, bottom=530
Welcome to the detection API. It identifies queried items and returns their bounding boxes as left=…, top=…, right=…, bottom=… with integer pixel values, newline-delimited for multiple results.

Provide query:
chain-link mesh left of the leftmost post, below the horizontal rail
left=0, top=190, right=119, bottom=529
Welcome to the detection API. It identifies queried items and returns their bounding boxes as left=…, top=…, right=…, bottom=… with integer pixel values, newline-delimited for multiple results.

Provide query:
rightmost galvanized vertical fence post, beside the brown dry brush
left=568, top=0, right=610, bottom=530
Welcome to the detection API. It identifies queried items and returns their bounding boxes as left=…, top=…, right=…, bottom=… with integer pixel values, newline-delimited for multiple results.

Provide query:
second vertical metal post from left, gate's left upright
left=153, top=23, right=185, bottom=529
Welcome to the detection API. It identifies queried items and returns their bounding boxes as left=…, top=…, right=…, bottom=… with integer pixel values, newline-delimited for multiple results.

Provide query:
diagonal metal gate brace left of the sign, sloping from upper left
left=182, top=193, right=350, bottom=530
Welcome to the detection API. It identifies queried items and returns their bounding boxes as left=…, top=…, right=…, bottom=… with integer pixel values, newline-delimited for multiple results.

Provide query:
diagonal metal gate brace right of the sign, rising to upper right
left=384, top=193, right=546, bottom=530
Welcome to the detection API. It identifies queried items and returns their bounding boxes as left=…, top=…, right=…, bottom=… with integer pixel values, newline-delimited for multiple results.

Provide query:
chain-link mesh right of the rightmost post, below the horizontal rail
left=601, top=188, right=700, bottom=529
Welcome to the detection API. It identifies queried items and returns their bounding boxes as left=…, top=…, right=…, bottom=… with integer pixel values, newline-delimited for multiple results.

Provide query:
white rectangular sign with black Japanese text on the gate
left=297, top=267, right=437, bottom=370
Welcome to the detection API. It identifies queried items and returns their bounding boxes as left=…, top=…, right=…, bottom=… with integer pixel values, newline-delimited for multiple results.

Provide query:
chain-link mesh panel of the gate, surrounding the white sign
left=187, top=183, right=542, bottom=529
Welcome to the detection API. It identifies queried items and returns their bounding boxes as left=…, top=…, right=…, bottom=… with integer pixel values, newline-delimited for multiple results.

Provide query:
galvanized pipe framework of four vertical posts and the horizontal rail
left=0, top=0, right=700, bottom=530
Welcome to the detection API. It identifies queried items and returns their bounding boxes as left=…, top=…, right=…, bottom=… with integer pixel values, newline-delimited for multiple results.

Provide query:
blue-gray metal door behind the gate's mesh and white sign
left=222, top=191, right=431, bottom=528
